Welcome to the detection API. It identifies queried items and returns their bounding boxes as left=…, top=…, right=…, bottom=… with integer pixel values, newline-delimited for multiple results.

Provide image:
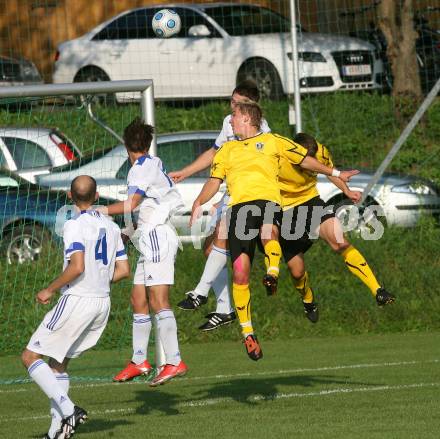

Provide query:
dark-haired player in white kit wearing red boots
left=102, top=118, right=188, bottom=386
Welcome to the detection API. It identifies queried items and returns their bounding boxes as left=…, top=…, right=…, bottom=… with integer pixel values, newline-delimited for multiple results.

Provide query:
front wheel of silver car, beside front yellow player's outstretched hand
left=334, top=198, right=386, bottom=236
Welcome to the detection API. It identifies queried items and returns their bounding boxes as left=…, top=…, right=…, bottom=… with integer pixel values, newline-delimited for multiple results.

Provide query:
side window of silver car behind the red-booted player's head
left=116, top=139, right=214, bottom=180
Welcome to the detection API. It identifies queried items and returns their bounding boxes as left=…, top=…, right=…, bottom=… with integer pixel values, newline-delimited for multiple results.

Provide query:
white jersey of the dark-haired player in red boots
left=127, top=155, right=183, bottom=228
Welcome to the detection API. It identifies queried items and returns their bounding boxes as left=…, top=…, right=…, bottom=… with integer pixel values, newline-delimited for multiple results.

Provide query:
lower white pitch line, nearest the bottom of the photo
left=0, top=382, right=440, bottom=424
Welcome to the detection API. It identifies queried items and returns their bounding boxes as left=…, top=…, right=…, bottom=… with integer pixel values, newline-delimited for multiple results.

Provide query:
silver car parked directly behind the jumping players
left=38, top=131, right=440, bottom=240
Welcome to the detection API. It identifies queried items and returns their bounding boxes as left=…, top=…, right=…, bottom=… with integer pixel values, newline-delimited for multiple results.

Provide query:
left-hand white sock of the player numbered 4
left=28, top=360, right=74, bottom=418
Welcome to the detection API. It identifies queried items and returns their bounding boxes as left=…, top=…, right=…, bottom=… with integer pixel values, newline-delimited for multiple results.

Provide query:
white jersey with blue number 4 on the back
left=62, top=210, right=127, bottom=297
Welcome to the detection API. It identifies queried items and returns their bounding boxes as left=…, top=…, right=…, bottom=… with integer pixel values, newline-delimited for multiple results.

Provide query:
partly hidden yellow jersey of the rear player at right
left=278, top=143, right=333, bottom=210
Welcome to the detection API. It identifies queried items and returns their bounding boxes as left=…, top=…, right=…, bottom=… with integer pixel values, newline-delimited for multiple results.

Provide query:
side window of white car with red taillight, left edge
left=3, top=137, right=52, bottom=171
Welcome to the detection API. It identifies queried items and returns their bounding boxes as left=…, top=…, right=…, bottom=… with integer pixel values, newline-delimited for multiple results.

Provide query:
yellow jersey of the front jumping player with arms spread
left=211, top=133, right=307, bottom=206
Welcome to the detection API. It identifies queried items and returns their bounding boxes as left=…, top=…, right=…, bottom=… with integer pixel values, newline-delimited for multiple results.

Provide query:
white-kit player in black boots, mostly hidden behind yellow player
left=169, top=81, right=270, bottom=331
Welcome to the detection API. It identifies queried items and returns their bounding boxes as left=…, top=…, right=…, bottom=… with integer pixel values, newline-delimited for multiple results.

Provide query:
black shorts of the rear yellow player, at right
left=280, top=197, right=335, bottom=262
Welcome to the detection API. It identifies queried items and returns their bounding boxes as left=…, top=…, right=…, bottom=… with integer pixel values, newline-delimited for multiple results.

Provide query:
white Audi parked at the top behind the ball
left=53, top=3, right=383, bottom=101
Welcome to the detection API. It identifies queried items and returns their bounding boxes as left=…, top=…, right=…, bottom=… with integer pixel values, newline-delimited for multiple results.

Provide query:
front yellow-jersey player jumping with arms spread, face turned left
left=191, top=101, right=358, bottom=360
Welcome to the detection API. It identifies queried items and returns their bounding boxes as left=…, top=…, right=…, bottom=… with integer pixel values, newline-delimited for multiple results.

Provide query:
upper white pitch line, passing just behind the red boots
left=0, top=359, right=440, bottom=394
